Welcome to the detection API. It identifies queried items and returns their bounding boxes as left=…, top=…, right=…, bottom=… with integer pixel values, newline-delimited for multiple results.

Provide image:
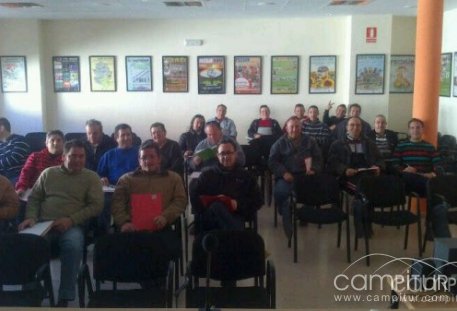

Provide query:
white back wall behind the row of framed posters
left=0, top=16, right=416, bottom=143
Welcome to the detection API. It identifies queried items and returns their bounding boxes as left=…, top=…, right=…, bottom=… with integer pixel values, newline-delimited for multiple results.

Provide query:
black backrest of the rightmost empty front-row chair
left=191, top=230, right=265, bottom=280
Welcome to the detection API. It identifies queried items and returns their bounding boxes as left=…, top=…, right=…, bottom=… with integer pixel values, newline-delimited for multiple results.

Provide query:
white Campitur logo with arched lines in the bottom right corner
left=333, top=253, right=457, bottom=302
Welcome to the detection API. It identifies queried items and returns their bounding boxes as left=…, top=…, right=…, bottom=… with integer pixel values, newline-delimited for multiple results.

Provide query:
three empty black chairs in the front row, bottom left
left=0, top=230, right=276, bottom=308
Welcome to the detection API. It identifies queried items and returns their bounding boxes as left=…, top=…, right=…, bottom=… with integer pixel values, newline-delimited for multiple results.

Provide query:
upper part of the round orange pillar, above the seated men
left=413, top=0, right=444, bottom=146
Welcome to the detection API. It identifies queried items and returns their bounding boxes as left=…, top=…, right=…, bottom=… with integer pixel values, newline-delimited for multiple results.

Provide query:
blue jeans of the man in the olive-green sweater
left=46, top=226, right=84, bottom=300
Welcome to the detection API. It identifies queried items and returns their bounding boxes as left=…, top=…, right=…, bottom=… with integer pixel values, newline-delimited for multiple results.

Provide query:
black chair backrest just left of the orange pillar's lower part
left=357, top=175, right=406, bottom=207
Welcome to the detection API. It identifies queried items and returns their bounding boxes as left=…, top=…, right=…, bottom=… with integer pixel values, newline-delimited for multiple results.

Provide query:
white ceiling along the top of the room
left=0, top=0, right=457, bottom=19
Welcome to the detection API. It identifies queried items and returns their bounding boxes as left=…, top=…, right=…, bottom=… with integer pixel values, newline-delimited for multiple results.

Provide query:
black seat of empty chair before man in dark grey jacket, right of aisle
left=297, top=206, right=347, bottom=224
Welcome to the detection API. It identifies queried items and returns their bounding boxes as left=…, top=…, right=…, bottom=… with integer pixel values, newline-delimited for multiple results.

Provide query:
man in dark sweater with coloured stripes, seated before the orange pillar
left=393, top=118, right=440, bottom=196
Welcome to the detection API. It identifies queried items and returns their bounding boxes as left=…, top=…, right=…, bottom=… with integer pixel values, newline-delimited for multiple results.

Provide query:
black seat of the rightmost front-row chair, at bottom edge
left=186, top=287, right=270, bottom=309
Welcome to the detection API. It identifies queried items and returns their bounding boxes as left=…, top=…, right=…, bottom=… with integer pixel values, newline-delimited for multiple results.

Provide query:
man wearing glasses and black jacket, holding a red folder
left=190, top=139, right=263, bottom=232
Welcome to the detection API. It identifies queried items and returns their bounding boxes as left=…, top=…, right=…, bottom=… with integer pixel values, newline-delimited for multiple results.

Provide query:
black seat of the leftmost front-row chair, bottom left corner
left=0, top=288, right=46, bottom=307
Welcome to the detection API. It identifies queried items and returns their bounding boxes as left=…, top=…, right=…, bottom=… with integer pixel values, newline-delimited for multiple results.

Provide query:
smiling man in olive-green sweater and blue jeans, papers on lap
left=19, top=140, right=103, bottom=307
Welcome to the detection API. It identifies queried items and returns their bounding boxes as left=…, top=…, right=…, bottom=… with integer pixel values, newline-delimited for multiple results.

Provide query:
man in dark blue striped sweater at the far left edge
left=0, top=118, right=30, bottom=185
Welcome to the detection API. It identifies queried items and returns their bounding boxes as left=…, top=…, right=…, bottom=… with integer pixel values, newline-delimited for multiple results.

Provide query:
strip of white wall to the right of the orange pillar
left=438, top=10, right=457, bottom=136
